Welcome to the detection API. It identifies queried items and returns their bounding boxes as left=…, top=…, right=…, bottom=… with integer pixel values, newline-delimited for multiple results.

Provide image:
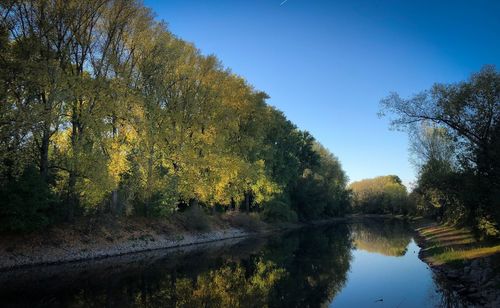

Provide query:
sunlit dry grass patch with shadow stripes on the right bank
left=417, top=224, right=500, bottom=265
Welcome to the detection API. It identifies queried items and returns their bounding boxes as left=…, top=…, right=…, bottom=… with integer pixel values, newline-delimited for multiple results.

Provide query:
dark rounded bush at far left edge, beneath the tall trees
left=0, top=166, right=53, bottom=232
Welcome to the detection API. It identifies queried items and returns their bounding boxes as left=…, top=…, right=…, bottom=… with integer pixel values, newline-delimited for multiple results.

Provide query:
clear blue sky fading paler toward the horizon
left=144, top=0, right=500, bottom=185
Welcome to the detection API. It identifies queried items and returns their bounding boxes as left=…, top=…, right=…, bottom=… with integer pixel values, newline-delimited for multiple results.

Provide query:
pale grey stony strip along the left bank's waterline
left=0, top=220, right=250, bottom=271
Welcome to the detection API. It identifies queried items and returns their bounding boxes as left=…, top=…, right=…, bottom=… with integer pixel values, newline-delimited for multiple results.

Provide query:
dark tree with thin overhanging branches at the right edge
left=381, top=66, right=500, bottom=234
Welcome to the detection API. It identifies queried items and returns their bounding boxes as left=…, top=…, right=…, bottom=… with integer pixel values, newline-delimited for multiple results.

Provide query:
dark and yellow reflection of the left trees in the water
left=4, top=225, right=352, bottom=307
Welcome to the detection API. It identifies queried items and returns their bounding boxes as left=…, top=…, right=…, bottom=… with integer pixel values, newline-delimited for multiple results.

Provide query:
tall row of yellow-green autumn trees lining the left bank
left=0, top=0, right=349, bottom=231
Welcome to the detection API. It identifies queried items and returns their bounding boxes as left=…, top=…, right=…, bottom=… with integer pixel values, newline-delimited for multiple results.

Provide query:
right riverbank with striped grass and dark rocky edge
left=413, top=219, right=500, bottom=307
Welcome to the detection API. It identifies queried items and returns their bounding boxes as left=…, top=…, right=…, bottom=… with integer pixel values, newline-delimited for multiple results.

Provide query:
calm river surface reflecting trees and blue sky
left=0, top=220, right=458, bottom=307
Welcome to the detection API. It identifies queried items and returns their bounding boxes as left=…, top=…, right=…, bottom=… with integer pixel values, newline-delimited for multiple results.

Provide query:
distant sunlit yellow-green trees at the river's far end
left=349, top=175, right=412, bottom=215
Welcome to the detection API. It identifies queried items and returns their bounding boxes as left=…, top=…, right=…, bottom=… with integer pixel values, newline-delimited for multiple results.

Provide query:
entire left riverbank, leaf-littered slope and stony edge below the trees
left=0, top=212, right=346, bottom=271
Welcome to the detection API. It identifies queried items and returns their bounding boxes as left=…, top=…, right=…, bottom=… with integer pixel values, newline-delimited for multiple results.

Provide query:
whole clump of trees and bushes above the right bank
left=381, top=66, right=500, bottom=236
